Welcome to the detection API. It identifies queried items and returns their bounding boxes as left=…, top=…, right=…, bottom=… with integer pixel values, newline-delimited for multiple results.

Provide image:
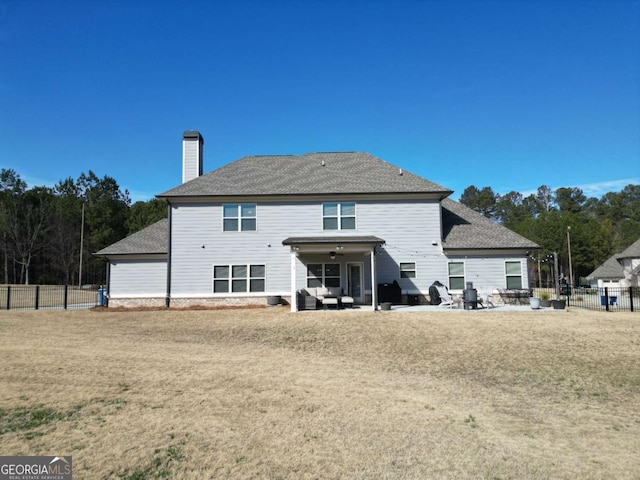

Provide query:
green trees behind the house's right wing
left=460, top=184, right=640, bottom=286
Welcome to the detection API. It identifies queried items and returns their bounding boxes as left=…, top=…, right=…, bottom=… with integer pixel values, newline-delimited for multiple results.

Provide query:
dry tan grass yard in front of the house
left=0, top=307, right=640, bottom=480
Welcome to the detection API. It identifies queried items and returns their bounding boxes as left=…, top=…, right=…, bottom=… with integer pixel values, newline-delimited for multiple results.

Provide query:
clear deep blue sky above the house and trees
left=0, top=0, right=640, bottom=201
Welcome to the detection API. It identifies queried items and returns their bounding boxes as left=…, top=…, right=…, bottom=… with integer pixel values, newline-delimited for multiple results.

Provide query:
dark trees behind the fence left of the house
left=0, top=169, right=167, bottom=285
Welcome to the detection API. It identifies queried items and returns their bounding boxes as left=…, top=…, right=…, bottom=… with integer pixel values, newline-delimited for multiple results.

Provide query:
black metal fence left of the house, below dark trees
left=0, top=285, right=105, bottom=310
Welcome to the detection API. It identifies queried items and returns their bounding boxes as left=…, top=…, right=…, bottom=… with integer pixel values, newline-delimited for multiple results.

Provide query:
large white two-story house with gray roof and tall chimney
left=96, top=131, right=539, bottom=311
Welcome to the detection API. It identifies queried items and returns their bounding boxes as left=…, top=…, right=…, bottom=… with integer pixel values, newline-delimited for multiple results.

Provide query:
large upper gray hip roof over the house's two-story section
left=157, top=152, right=453, bottom=198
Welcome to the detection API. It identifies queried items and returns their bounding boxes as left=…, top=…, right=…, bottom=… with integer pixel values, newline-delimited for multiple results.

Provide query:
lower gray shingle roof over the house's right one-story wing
left=442, top=198, right=540, bottom=250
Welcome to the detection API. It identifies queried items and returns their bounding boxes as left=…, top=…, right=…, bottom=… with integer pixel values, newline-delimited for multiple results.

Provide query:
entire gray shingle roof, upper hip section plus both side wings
left=95, top=152, right=540, bottom=256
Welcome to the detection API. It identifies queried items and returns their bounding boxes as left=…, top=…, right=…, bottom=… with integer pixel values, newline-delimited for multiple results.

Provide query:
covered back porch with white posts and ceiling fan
left=282, top=235, right=385, bottom=312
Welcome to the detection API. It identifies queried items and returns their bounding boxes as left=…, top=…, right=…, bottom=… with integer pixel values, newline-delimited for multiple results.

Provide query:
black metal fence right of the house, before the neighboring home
left=534, top=287, right=640, bottom=312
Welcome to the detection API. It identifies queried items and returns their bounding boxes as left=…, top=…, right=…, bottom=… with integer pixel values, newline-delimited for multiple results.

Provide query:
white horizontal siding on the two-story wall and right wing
left=163, top=199, right=528, bottom=298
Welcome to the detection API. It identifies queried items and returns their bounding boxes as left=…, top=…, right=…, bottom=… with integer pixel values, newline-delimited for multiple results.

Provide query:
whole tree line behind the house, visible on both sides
left=0, top=169, right=640, bottom=285
